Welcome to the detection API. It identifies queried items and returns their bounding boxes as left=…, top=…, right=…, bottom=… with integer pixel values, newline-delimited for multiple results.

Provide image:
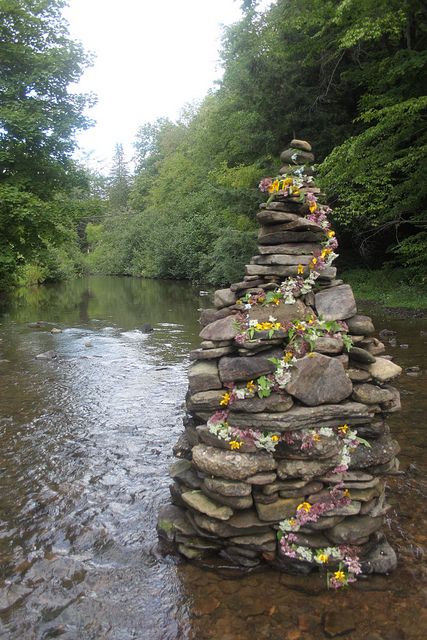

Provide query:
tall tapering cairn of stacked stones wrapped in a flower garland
left=158, top=140, right=401, bottom=588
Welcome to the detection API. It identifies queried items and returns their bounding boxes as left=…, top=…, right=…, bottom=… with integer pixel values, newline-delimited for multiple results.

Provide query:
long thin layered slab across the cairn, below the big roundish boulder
left=228, top=402, right=374, bottom=431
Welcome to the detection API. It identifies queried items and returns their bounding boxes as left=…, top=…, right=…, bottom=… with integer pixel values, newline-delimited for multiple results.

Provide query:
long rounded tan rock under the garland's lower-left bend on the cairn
left=193, top=444, right=277, bottom=480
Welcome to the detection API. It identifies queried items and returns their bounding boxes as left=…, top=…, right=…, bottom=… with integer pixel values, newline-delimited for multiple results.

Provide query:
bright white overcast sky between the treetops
left=65, top=0, right=244, bottom=170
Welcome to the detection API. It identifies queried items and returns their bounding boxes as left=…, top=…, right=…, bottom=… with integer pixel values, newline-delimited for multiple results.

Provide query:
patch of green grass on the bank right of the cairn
left=340, top=269, right=427, bottom=310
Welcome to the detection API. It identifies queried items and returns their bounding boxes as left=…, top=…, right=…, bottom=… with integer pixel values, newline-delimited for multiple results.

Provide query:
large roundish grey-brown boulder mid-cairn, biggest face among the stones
left=285, top=354, right=353, bottom=407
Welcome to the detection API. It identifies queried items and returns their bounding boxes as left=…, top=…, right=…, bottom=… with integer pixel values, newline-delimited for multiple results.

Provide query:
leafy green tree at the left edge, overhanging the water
left=0, top=0, right=93, bottom=284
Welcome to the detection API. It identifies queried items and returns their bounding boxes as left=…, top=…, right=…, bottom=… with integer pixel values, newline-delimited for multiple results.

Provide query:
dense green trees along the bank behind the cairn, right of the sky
left=0, top=0, right=427, bottom=284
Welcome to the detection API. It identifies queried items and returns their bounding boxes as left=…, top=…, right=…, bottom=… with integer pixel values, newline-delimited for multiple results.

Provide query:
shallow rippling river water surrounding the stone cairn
left=0, top=277, right=427, bottom=640
